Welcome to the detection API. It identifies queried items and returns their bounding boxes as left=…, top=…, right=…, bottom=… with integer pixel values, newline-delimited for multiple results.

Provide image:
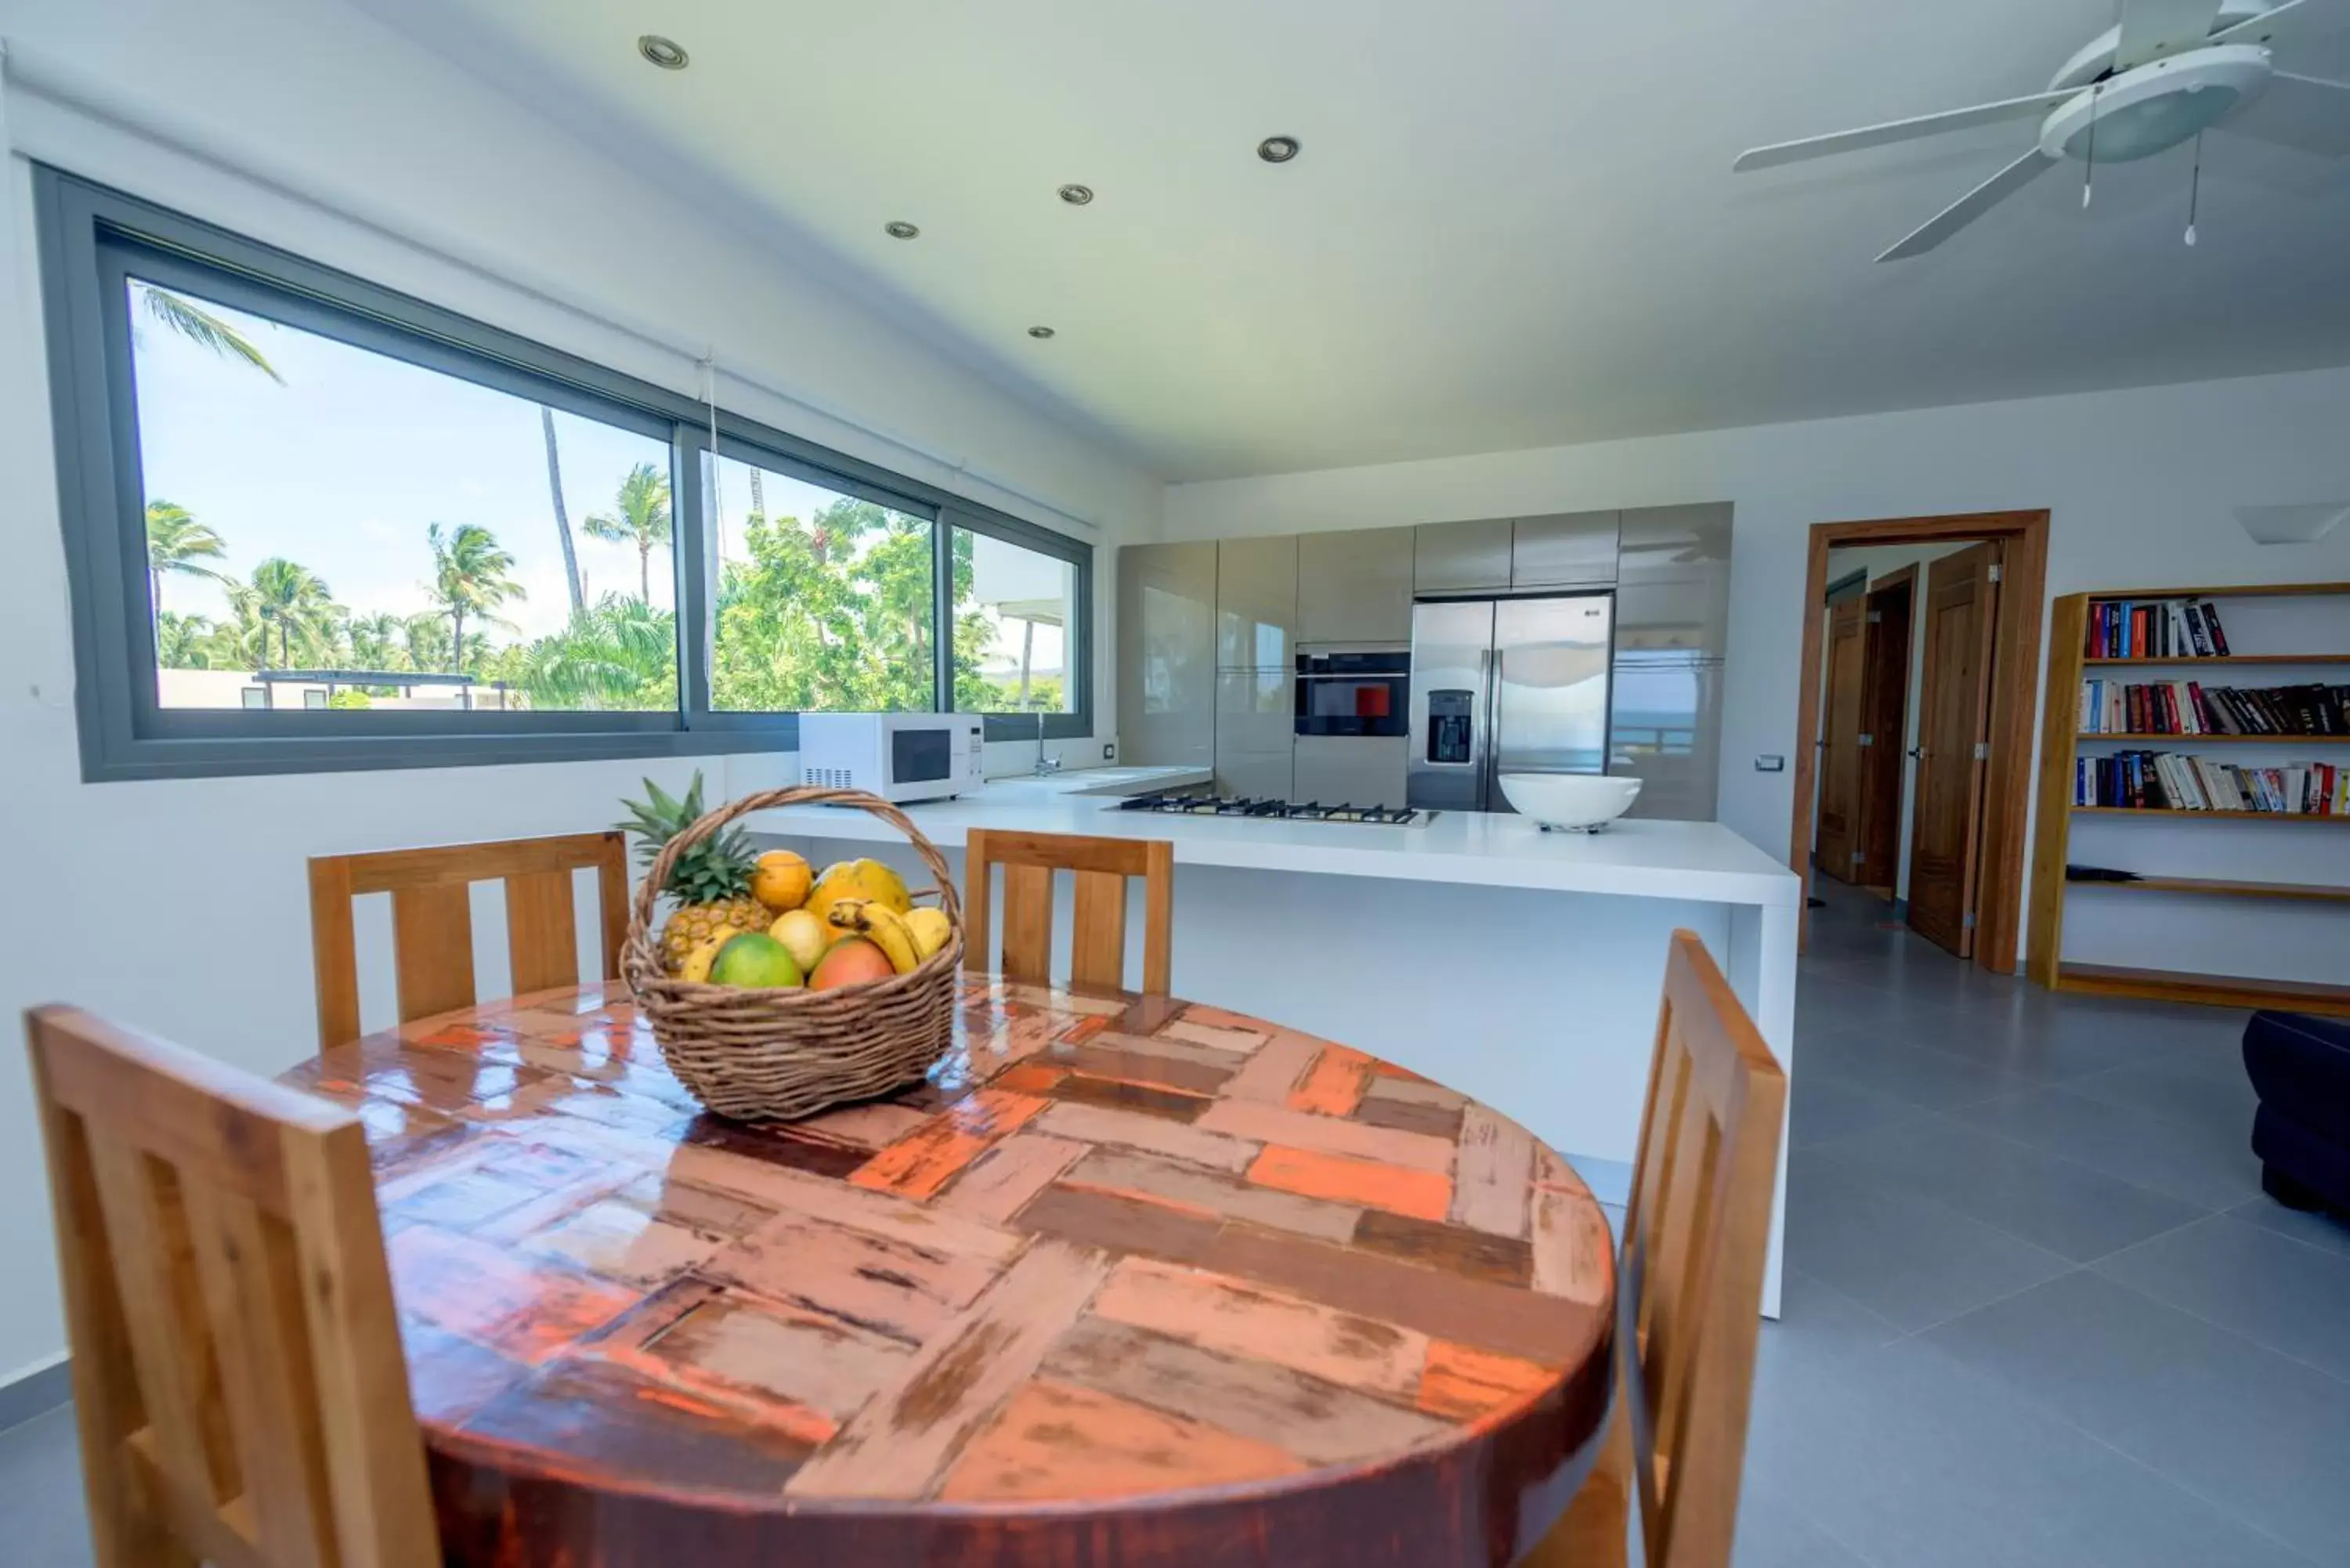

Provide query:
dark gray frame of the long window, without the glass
left=33, top=164, right=1097, bottom=782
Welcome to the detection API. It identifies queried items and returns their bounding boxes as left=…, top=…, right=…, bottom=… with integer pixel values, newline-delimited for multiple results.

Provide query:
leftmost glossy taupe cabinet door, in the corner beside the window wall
left=1119, top=540, right=1215, bottom=766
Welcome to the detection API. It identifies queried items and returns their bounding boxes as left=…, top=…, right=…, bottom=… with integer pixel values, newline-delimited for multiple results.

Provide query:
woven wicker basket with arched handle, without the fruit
left=620, top=788, right=964, bottom=1122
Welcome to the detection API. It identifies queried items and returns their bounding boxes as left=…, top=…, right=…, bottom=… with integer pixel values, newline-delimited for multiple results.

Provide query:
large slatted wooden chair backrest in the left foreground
left=26, top=1009, right=442, bottom=1568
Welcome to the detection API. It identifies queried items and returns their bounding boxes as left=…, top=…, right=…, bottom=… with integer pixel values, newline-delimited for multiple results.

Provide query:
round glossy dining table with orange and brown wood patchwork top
left=287, top=976, right=1614, bottom=1568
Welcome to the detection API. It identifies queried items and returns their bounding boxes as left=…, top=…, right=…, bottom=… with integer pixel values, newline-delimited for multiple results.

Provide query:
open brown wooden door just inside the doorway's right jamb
left=1908, top=543, right=2000, bottom=959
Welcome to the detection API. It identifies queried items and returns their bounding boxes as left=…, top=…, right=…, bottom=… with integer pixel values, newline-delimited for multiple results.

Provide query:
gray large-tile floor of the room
left=0, top=884, right=2350, bottom=1568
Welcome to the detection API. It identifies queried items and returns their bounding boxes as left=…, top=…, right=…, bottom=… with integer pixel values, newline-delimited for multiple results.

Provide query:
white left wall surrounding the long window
left=0, top=0, right=1159, bottom=1382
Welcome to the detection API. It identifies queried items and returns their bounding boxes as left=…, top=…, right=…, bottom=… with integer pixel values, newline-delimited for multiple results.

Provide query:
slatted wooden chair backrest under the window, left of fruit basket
left=310, top=833, right=627, bottom=1051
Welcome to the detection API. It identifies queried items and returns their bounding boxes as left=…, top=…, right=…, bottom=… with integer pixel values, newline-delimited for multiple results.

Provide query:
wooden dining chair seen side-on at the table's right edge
left=1525, top=931, right=1786, bottom=1568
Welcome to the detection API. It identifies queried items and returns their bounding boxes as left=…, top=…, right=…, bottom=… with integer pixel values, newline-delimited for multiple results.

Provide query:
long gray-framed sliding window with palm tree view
left=35, top=169, right=1093, bottom=778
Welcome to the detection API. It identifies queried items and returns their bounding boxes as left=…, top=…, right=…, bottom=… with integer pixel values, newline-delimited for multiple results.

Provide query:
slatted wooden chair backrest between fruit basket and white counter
left=964, top=828, right=1175, bottom=997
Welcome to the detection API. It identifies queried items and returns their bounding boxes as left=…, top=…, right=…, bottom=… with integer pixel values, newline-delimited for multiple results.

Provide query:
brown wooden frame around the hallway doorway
left=1786, top=508, right=2049, bottom=976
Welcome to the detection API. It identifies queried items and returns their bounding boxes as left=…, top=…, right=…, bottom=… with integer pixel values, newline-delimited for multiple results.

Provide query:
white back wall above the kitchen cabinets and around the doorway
left=1166, top=367, right=2350, bottom=921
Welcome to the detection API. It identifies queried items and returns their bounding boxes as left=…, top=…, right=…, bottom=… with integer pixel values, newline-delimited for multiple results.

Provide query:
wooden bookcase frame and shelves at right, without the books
left=2026, top=583, right=2350, bottom=1016
